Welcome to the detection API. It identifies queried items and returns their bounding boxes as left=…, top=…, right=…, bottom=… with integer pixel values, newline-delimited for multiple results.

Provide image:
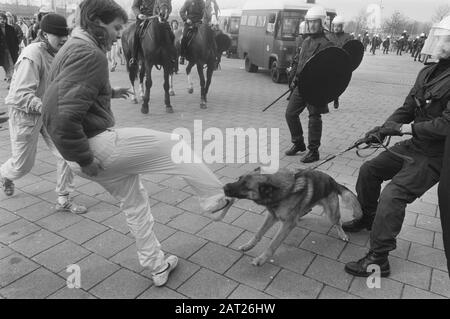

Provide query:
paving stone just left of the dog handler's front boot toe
left=305, top=256, right=353, bottom=291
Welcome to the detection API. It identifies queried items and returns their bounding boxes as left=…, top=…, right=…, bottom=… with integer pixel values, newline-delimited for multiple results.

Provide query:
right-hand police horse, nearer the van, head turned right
left=180, top=23, right=231, bottom=109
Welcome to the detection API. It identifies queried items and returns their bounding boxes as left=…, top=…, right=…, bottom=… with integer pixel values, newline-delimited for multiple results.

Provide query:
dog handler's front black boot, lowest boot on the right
left=345, top=251, right=391, bottom=277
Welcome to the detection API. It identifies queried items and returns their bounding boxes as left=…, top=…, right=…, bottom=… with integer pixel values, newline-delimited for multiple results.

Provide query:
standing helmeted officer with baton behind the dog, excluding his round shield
left=286, top=6, right=333, bottom=163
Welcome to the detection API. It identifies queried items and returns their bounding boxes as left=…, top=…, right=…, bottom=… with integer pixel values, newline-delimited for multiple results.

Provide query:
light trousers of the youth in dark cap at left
left=0, top=107, right=74, bottom=195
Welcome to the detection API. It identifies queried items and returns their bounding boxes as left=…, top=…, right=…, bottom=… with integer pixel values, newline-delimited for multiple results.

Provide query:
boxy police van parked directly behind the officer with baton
left=238, top=0, right=336, bottom=83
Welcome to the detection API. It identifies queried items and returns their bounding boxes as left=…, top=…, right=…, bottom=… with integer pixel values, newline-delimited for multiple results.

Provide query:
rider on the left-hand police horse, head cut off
left=129, top=0, right=175, bottom=67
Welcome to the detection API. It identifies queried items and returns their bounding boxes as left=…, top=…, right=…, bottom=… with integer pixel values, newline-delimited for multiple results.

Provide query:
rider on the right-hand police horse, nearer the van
left=180, top=0, right=217, bottom=65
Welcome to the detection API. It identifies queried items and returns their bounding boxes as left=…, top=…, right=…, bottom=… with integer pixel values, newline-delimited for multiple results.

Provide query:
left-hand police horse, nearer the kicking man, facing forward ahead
left=122, top=0, right=176, bottom=114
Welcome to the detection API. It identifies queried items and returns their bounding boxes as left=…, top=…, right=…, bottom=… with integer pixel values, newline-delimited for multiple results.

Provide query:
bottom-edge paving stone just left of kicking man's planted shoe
left=89, top=269, right=151, bottom=299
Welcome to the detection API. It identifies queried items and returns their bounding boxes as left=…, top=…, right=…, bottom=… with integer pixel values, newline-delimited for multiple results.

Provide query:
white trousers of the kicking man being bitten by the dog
left=69, top=128, right=226, bottom=273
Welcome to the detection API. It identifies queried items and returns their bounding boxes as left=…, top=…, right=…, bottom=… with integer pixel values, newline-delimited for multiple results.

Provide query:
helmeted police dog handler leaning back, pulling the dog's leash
left=343, top=17, right=450, bottom=277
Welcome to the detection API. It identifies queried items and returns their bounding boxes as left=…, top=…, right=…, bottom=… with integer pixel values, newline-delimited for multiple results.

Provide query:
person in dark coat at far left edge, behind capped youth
left=0, top=12, right=19, bottom=83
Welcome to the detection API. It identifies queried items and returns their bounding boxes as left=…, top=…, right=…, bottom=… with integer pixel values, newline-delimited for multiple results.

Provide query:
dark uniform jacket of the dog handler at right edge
left=388, top=59, right=450, bottom=157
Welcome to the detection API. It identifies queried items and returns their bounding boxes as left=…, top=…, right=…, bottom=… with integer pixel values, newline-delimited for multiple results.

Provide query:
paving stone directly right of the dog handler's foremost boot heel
left=389, top=256, right=431, bottom=290
